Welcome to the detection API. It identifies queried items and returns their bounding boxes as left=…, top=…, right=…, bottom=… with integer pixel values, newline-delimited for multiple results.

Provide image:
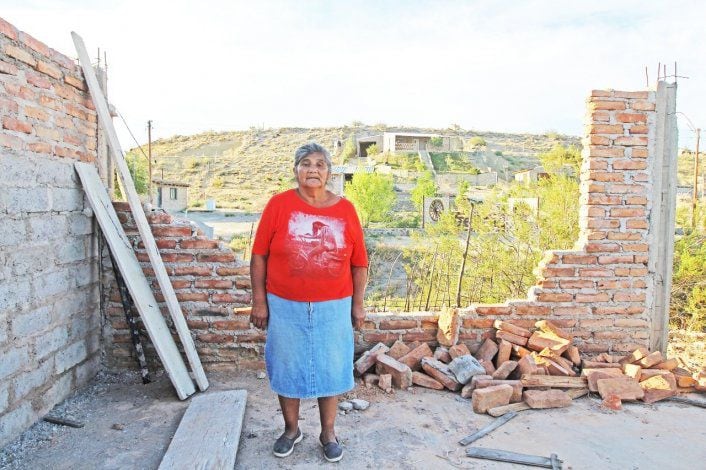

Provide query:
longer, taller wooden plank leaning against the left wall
left=71, top=32, right=208, bottom=390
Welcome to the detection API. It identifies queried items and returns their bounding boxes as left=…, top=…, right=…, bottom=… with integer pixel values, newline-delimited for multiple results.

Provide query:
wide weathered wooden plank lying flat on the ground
left=159, top=390, right=248, bottom=470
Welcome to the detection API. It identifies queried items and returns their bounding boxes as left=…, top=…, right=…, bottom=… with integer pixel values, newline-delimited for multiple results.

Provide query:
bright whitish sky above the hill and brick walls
left=0, top=0, right=706, bottom=149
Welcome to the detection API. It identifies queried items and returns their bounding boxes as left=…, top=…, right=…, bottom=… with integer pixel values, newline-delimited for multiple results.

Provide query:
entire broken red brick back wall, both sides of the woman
left=106, top=90, right=656, bottom=368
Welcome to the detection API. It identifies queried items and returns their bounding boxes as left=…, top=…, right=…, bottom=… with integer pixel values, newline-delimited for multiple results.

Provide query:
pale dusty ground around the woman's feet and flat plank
left=0, top=372, right=706, bottom=470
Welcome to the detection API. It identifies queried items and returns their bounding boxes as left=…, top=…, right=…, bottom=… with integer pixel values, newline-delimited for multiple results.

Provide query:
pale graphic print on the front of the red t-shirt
left=288, top=212, right=346, bottom=278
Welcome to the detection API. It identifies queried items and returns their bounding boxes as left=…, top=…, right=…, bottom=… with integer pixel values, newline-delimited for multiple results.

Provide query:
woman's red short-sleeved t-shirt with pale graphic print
left=252, top=189, right=368, bottom=302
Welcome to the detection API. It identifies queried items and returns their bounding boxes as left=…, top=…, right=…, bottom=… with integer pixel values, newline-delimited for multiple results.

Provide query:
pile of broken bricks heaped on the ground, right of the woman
left=355, top=320, right=706, bottom=416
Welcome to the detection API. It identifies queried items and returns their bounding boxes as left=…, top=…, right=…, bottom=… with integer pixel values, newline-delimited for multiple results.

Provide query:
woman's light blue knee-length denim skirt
left=265, top=293, right=354, bottom=398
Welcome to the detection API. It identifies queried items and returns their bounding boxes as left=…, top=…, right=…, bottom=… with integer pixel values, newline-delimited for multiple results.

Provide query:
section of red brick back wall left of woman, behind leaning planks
left=103, top=202, right=264, bottom=369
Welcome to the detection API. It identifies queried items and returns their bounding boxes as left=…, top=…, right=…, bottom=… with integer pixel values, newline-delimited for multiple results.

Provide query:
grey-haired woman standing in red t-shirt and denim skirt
left=250, top=142, right=368, bottom=462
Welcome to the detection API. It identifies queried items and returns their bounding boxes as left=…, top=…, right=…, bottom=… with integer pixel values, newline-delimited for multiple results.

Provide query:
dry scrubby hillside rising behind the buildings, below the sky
left=138, top=125, right=579, bottom=211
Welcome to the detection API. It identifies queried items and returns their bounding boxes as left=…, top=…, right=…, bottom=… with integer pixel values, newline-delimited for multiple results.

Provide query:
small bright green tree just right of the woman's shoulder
left=345, top=171, right=397, bottom=227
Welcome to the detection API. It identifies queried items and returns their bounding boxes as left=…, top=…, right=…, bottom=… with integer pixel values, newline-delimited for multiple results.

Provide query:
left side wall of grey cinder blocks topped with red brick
left=0, top=19, right=101, bottom=447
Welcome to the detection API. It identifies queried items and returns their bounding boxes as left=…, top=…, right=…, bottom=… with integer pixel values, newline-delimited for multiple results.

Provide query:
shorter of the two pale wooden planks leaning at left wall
left=74, top=162, right=196, bottom=400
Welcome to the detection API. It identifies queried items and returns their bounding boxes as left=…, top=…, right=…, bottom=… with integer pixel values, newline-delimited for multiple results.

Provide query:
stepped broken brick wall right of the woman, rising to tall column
left=359, top=90, right=656, bottom=353
